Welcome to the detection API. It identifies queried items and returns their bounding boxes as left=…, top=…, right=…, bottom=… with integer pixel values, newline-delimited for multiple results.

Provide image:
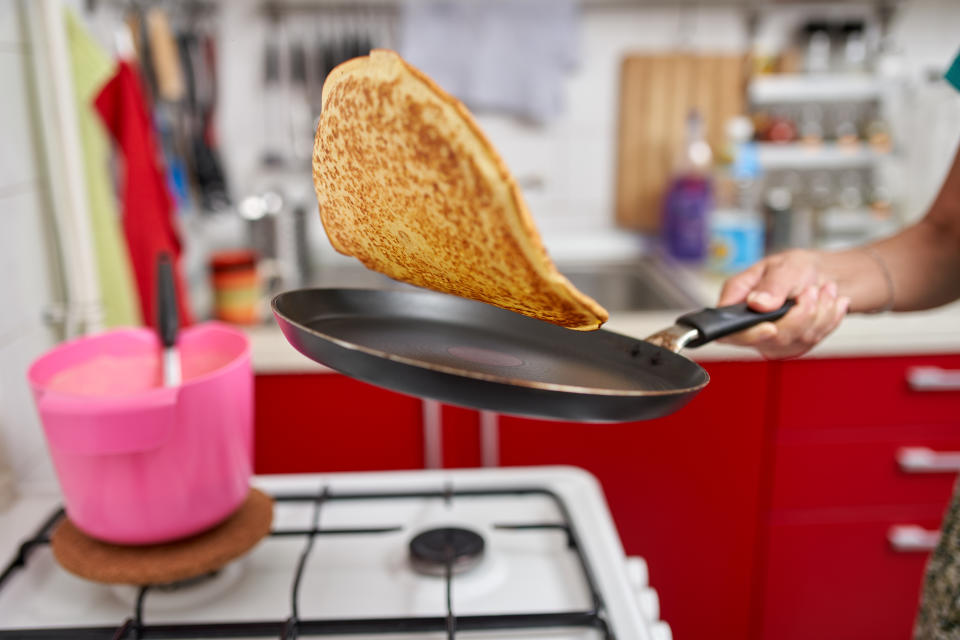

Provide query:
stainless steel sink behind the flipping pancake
left=313, top=258, right=702, bottom=312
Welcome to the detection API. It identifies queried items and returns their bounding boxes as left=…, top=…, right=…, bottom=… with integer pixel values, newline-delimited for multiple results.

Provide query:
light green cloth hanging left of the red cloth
left=65, top=8, right=143, bottom=328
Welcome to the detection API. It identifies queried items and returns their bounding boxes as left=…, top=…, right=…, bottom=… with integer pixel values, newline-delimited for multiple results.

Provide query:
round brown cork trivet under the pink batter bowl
left=50, top=489, right=273, bottom=585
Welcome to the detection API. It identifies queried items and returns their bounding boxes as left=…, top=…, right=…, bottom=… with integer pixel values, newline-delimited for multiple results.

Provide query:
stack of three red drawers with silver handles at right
left=754, top=355, right=960, bottom=640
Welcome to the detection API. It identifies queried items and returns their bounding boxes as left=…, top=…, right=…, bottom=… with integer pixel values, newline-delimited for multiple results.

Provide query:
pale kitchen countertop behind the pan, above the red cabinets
left=246, top=282, right=960, bottom=373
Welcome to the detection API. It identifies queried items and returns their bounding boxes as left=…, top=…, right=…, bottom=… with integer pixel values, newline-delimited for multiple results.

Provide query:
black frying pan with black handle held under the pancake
left=273, top=289, right=793, bottom=422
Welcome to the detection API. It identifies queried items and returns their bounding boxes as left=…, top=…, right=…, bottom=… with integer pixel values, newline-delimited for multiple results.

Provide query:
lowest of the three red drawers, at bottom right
left=761, top=509, right=940, bottom=640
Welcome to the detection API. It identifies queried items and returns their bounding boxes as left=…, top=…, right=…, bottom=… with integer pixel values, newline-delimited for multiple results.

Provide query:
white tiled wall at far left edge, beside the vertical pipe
left=0, top=0, right=61, bottom=503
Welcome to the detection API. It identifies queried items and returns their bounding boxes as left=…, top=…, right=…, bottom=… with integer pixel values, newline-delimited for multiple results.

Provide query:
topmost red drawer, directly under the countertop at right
left=774, top=355, right=960, bottom=429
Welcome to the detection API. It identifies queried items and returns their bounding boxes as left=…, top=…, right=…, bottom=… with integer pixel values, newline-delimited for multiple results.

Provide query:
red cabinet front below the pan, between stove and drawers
left=500, top=361, right=767, bottom=640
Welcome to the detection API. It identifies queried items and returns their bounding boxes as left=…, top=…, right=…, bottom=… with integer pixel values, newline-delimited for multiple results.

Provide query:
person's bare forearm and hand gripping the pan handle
left=719, top=141, right=960, bottom=357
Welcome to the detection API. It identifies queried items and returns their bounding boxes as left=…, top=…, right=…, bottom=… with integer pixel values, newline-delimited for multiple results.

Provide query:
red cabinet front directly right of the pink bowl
left=254, top=374, right=423, bottom=473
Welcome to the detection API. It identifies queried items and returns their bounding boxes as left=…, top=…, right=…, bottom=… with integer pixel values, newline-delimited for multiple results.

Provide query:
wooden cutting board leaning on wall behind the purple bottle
left=616, top=53, right=745, bottom=232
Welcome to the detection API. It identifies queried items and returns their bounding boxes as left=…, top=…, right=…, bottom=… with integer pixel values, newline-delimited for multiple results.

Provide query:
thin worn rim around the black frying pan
left=270, top=287, right=710, bottom=398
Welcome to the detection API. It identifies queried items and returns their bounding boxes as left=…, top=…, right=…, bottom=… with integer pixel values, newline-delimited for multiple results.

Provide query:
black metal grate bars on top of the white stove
left=0, top=485, right=616, bottom=640
